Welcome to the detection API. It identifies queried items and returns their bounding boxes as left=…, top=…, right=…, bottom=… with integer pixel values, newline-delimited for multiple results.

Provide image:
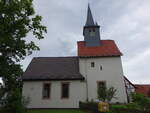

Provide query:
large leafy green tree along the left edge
left=0, top=0, right=46, bottom=113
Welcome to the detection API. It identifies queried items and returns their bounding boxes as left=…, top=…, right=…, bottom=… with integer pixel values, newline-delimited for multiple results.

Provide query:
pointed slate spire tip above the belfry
left=85, top=3, right=94, bottom=26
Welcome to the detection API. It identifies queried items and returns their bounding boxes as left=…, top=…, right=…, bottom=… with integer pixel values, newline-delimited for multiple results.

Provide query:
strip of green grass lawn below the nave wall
left=28, top=109, right=89, bottom=113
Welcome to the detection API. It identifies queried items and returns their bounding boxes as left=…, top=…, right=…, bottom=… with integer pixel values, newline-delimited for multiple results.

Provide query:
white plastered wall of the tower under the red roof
left=79, top=57, right=127, bottom=103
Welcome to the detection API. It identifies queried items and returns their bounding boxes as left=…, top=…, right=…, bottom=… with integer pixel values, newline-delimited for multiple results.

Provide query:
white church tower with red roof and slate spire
left=77, top=5, right=127, bottom=103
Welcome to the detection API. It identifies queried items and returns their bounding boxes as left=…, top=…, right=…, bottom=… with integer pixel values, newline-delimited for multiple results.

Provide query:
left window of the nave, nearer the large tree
left=43, top=83, right=51, bottom=99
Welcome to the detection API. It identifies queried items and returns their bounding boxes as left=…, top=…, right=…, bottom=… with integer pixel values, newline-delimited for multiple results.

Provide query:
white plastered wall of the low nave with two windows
left=23, top=80, right=86, bottom=108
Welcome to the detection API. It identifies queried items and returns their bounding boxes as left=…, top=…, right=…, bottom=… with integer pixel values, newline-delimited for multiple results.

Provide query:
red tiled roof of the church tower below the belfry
left=78, top=40, right=122, bottom=57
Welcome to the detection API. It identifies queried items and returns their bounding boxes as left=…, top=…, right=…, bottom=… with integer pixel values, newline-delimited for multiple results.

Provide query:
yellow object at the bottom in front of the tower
left=98, top=102, right=109, bottom=112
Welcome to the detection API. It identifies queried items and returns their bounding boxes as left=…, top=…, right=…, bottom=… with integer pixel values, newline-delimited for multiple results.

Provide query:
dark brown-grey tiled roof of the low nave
left=23, top=57, right=84, bottom=81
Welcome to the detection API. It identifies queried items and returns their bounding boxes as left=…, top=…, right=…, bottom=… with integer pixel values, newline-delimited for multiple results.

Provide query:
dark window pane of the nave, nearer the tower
left=61, top=83, right=69, bottom=98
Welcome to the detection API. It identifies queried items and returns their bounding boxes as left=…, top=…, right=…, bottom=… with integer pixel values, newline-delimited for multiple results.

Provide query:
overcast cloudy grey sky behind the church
left=18, top=0, right=150, bottom=84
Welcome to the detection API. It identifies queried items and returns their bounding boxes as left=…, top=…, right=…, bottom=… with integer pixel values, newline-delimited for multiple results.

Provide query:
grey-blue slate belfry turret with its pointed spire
left=83, top=5, right=101, bottom=47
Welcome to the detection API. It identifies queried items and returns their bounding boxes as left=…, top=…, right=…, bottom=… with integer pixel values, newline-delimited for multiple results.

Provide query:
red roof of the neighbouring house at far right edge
left=135, top=84, right=150, bottom=96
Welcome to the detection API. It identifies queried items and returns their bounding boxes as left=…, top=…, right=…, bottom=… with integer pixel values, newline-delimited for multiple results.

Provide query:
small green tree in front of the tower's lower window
left=97, top=87, right=117, bottom=102
